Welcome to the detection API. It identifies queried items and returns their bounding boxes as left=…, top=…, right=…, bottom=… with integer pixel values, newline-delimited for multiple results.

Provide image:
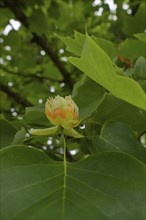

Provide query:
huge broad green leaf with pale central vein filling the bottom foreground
left=1, top=146, right=146, bottom=220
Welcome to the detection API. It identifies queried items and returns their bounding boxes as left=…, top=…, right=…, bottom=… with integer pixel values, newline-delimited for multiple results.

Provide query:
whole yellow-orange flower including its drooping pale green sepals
left=30, top=95, right=83, bottom=138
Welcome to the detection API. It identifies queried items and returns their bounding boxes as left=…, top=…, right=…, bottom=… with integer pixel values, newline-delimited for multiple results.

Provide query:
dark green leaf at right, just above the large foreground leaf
left=93, top=121, right=146, bottom=163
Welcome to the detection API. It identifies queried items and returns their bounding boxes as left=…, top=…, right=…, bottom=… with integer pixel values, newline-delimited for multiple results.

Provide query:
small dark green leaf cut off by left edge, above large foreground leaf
left=0, top=119, right=17, bottom=148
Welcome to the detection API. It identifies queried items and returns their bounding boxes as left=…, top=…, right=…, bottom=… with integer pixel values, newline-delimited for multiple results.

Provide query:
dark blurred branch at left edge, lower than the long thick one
left=0, top=82, right=32, bottom=107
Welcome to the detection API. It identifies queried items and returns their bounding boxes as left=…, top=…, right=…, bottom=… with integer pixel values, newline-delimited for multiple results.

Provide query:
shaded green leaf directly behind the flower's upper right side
left=73, top=78, right=105, bottom=120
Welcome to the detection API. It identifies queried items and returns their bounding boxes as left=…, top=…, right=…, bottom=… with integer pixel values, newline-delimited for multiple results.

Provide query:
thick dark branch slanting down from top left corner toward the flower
left=3, top=0, right=73, bottom=88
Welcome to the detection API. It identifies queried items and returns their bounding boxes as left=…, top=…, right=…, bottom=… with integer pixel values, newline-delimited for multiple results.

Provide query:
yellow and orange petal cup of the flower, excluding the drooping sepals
left=45, top=95, right=80, bottom=128
